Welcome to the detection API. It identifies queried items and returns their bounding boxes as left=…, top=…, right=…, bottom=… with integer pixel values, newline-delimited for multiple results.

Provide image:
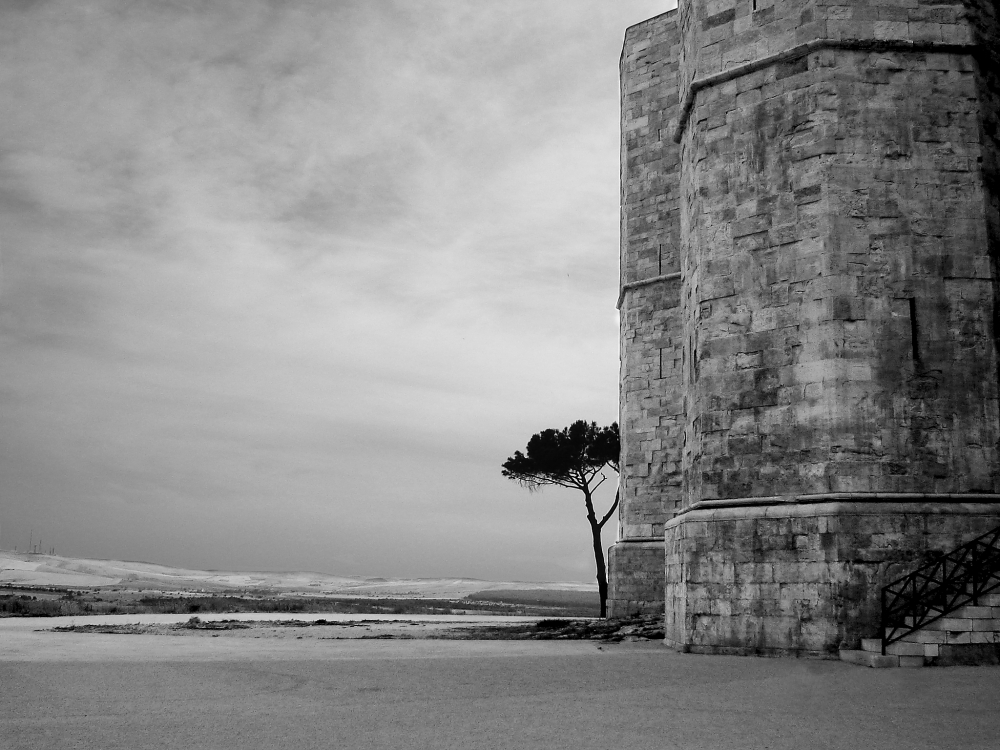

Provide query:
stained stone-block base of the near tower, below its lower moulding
left=666, top=502, right=1000, bottom=657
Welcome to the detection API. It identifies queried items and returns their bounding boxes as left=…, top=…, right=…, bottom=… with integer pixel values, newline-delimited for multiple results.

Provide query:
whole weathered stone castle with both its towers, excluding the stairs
left=610, top=0, right=1000, bottom=653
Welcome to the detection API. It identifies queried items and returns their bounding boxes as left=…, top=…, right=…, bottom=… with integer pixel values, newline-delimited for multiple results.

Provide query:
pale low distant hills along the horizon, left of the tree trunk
left=0, top=550, right=597, bottom=599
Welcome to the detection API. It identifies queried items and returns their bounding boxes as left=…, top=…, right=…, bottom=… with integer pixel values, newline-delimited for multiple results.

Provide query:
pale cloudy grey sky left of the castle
left=0, top=0, right=674, bottom=581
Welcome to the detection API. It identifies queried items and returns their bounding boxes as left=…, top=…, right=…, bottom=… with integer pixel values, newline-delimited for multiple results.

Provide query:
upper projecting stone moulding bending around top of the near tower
left=673, top=39, right=979, bottom=143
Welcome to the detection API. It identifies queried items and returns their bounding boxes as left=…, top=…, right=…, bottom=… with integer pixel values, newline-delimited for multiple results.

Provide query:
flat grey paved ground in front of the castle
left=0, top=633, right=1000, bottom=750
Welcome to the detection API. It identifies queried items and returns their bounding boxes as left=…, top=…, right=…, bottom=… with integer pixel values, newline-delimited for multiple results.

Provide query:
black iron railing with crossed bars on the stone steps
left=882, top=526, right=1000, bottom=654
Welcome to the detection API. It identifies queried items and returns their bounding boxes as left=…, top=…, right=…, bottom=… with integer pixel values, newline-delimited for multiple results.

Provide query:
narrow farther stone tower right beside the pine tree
left=608, top=12, right=683, bottom=616
